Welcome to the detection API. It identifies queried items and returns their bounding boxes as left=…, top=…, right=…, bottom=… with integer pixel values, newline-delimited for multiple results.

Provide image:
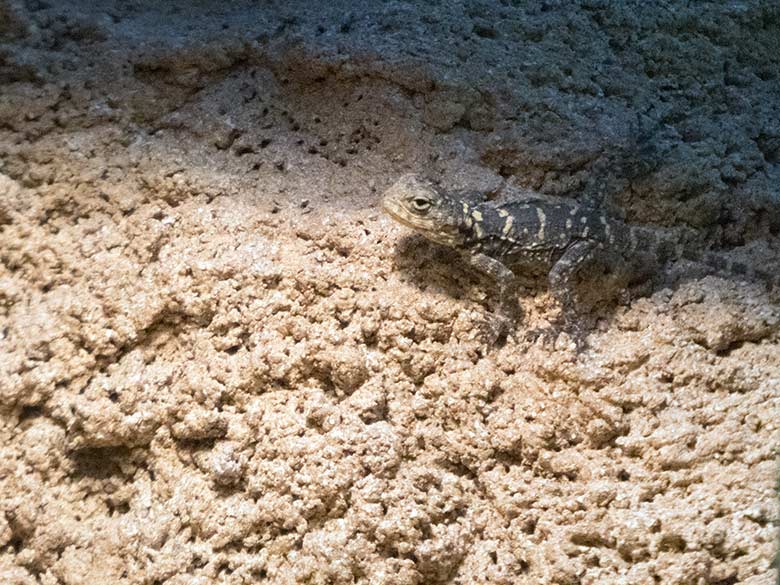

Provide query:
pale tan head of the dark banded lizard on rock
left=382, top=175, right=463, bottom=246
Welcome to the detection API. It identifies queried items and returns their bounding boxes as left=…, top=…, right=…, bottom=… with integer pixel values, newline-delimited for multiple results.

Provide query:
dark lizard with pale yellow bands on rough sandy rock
left=382, top=174, right=772, bottom=330
